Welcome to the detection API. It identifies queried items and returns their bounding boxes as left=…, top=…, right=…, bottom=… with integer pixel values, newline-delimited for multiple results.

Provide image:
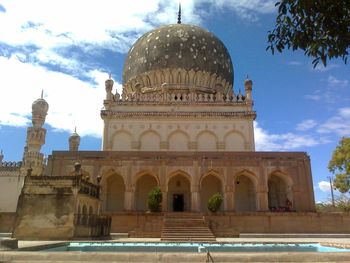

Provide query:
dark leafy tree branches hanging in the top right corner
left=266, top=0, right=350, bottom=67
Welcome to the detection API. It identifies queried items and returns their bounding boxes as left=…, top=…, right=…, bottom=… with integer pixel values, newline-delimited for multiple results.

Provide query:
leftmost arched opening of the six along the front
left=103, top=174, right=125, bottom=212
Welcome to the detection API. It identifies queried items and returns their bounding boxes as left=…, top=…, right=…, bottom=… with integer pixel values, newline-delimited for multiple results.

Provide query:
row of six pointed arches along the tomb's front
left=102, top=170, right=298, bottom=212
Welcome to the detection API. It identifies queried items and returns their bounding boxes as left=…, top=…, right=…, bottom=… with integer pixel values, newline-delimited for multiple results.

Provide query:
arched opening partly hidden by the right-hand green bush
left=200, top=174, right=224, bottom=212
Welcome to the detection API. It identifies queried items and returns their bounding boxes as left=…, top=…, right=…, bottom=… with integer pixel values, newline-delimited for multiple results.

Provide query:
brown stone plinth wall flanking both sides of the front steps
left=111, top=212, right=350, bottom=237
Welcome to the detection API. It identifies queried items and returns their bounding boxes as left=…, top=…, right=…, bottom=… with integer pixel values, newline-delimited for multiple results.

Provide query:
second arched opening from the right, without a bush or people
left=234, top=175, right=256, bottom=212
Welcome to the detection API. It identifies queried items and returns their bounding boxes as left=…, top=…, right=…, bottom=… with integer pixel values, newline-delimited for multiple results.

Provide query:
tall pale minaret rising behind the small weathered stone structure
left=21, top=92, right=49, bottom=175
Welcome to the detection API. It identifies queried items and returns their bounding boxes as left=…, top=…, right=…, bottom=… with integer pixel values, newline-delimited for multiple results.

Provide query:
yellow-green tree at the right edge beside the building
left=328, top=137, right=350, bottom=193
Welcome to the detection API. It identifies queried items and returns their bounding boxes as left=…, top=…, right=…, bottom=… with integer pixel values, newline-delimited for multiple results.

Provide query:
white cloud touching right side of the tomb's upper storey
left=254, top=122, right=329, bottom=151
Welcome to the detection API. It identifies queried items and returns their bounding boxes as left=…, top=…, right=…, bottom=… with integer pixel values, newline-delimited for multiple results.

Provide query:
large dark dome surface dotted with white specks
left=123, top=24, right=233, bottom=85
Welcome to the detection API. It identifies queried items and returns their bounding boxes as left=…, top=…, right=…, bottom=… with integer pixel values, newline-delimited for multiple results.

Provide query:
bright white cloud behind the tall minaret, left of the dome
left=0, top=56, right=120, bottom=137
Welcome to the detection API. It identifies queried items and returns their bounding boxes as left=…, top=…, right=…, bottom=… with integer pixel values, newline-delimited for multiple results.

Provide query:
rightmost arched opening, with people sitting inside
left=268, top=174, right=292, bottom=211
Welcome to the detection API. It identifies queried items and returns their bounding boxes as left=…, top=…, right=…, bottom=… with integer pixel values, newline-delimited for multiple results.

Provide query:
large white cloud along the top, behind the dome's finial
left=0, top=0, right=274, bottom=85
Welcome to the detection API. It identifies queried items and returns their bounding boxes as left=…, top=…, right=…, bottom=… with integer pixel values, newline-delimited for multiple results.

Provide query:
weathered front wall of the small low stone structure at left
left=14, top=176, right=76, bottom=240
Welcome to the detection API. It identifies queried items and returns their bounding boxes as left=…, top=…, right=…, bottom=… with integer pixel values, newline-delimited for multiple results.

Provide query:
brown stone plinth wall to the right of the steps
left=205, top=213, right=350, bottom=236
